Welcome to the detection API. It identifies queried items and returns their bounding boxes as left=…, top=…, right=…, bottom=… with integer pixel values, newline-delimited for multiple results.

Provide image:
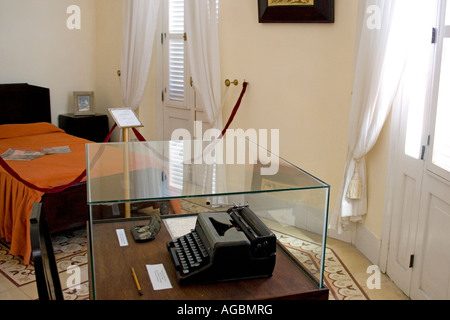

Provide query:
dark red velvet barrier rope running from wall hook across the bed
left=0, top=82, right=248, bottom=193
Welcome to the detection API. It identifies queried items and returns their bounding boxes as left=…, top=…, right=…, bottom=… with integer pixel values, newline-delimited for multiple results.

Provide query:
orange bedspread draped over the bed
left=0, top=123, right=90, bottom=264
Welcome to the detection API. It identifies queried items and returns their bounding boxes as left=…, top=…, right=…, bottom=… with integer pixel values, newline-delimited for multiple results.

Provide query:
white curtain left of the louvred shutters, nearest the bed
left=120, top=0, right=161, bottom=110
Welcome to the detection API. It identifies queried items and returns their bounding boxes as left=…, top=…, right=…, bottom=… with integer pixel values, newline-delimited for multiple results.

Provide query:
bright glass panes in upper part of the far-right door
left=403, top=0, right=450, bottom=180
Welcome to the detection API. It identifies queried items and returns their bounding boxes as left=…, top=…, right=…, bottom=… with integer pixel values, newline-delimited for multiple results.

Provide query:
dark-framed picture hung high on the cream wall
left=258, top=0, right=334, bottom=23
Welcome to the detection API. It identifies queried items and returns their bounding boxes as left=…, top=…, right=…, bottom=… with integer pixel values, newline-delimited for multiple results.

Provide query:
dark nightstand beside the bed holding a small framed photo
left=58, top=113, right=109, bottom=142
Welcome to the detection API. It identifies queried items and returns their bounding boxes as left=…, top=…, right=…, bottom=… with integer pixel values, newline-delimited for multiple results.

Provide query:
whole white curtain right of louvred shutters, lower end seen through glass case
left=185, top=0, right=227, bottom=205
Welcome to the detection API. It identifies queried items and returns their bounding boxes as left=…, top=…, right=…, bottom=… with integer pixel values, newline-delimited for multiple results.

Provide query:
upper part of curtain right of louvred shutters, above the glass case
left=185, top=0, right=222, bottom=129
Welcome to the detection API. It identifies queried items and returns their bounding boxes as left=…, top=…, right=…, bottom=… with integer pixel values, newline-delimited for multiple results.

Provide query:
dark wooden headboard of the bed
left=0, top=83, right=52, bottom=124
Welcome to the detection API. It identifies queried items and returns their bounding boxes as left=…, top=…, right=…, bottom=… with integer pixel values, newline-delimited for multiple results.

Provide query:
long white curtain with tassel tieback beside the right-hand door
left=329, top=0, right=412, bottom=233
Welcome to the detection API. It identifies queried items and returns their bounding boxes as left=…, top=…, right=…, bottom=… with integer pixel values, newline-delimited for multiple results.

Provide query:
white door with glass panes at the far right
left=387, top=0, right=450, bottom=299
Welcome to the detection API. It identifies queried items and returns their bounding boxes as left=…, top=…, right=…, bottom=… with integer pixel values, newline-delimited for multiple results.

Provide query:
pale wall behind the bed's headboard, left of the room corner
left=0, top=0, right=96, bottom=124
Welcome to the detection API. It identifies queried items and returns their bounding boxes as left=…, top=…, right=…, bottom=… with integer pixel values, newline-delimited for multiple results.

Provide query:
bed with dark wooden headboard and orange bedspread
left=0, top=83, right=91, bottom=264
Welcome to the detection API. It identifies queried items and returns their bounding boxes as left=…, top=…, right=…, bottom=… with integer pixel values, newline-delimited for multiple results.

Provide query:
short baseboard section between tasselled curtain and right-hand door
left=353, top=223, right=381, bottom=265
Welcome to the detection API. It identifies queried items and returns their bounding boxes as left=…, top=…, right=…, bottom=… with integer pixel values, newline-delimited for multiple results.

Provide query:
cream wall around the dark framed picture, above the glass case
left=220, top=0, right=358, bottom=224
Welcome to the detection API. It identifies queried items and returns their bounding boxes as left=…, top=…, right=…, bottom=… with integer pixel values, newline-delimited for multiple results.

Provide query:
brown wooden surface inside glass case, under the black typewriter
left=90, top=218, right=328, bottom=300
